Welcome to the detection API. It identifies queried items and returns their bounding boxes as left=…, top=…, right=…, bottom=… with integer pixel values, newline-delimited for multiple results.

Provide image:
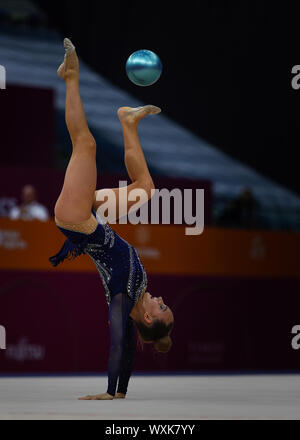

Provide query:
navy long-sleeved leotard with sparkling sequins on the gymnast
left=50, top=213, right=147, bottom=396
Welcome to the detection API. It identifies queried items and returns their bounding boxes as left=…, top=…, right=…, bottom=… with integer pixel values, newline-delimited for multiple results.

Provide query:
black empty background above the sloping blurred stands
left=37, top=0, right=300, bottom=194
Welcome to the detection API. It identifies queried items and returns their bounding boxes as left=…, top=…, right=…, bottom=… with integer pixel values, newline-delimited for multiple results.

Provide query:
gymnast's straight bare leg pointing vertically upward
left=55, top=39, right=97, bottom=233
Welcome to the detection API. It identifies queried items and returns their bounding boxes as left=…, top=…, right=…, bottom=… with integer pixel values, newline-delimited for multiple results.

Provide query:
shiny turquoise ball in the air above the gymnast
left=126, top=50, right=163, bottom=87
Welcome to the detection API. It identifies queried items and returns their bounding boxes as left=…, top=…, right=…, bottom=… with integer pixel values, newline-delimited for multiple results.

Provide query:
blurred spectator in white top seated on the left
left=10, top=185, right=49, bottom=222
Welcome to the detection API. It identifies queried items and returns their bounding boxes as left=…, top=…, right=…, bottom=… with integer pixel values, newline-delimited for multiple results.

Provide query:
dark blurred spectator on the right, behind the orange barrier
left=217, top=188, right=260, bottom=229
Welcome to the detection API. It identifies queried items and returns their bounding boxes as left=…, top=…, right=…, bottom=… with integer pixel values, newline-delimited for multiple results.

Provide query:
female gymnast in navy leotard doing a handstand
left=50, top=39, right=174, bottom=400
